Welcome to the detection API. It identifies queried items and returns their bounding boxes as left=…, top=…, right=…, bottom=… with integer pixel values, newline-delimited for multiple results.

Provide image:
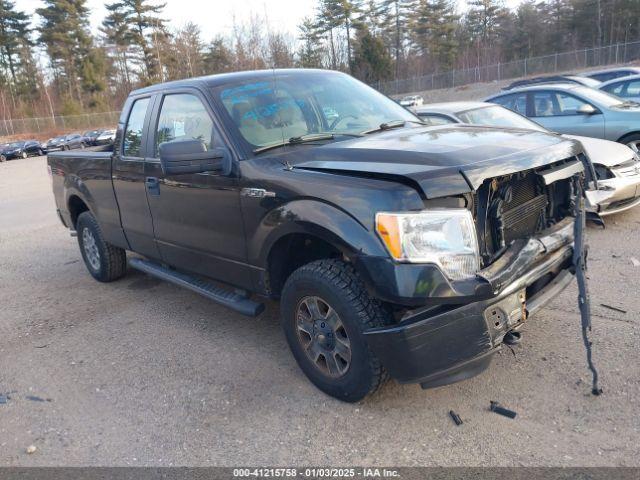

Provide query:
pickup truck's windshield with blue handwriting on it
left=215, top=72, right=419, bottom=149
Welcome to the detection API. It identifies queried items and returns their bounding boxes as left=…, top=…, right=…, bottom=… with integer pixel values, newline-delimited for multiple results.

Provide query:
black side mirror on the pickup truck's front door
left=159, top=139, right=231, bottom=175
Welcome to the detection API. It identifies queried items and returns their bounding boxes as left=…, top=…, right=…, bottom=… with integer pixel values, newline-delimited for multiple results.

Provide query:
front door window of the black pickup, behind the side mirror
left=156, top=93, right=213, bottom=153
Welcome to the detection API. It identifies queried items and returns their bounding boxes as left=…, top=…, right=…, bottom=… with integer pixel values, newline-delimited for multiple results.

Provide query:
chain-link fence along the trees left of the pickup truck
left=0, top=112, right=120, bottom=137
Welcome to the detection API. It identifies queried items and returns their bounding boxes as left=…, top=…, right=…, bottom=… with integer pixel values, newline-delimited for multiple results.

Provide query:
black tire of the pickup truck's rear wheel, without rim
left=76, top=212, right=127, bottom=282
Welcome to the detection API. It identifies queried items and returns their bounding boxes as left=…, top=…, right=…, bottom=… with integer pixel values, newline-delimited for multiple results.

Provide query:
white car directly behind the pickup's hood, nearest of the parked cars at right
left=416, top=102, right=640, bottom=216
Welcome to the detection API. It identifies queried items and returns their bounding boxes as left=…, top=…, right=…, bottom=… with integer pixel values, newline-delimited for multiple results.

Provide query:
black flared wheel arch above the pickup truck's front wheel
left=252, top=199, right=387, bottom=268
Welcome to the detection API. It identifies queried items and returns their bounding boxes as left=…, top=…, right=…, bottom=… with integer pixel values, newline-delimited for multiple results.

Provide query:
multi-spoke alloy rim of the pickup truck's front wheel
left=296, top=296, right=351, bottom=378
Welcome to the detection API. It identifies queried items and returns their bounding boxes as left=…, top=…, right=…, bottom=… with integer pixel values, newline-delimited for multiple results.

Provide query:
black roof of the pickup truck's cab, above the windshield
left=131, top=68, right=345, bottom=95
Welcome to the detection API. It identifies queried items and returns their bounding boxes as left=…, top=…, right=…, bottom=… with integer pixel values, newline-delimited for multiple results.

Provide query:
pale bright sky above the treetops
left=23, top=0, right=521, bottom=39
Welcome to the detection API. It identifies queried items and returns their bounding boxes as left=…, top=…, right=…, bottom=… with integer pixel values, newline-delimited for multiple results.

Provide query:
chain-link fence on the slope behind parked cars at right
left=372, top=41, right=640, bottom=95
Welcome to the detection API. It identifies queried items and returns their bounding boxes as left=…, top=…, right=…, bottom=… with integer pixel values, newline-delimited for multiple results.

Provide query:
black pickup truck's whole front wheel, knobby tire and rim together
left=281, top=260, right=388, bottom=402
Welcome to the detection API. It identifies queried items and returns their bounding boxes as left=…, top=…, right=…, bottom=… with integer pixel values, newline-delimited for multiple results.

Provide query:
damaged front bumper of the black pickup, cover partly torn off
left=365, top=219, right=574, bottom=388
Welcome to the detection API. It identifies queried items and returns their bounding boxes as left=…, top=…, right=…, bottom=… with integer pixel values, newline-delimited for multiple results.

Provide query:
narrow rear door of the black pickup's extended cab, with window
left=111, top=96, right=160, bottom=258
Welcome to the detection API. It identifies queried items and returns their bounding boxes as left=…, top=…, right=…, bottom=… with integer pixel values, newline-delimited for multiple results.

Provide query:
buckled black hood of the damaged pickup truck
left=292, top=125, right=582, bottom=198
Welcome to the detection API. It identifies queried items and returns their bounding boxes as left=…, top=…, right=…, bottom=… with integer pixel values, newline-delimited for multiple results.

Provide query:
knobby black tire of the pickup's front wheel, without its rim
left=280, top=260, right=390, bottom=402
